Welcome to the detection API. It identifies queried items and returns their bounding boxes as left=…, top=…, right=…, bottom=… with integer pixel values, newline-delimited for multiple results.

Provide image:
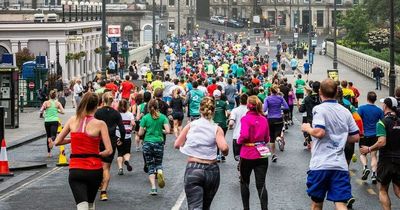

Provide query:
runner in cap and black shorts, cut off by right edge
left=360, top=97, right=400, bottom=210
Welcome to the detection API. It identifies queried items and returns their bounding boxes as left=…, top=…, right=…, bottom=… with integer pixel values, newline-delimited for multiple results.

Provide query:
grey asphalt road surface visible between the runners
left=0, top=28, right=400, bottom=210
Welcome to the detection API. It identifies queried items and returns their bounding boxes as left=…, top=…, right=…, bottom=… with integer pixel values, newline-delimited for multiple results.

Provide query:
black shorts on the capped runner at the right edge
left=376, top=158, right=400, bottom=186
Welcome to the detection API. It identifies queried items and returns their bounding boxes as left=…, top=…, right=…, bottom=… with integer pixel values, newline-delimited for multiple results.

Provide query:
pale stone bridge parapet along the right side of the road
left=326, top=42, right=400, bottom=86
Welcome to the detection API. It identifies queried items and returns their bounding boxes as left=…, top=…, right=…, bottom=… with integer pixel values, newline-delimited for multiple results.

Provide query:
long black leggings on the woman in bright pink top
left=239, top=158, right=268, bottom=210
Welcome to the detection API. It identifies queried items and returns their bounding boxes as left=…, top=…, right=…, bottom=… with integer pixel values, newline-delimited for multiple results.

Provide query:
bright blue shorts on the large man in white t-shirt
left=307, top=170, right=353, bottom=202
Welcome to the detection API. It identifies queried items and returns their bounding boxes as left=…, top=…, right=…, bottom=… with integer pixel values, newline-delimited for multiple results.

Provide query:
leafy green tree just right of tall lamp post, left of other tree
left=338, top=5, right=370, bottom=43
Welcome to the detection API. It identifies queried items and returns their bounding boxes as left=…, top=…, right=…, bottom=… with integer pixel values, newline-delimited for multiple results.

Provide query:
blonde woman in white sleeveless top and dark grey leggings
left=174, top=97, right=229, bottom=210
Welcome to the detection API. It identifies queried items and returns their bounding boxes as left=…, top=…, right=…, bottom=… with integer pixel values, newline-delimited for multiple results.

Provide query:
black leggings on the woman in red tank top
left=68, top=169, right=103, bottom=204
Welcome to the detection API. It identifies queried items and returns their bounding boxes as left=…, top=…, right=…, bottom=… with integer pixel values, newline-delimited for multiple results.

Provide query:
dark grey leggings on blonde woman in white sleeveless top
left=185, top=163, right=220, bottom=210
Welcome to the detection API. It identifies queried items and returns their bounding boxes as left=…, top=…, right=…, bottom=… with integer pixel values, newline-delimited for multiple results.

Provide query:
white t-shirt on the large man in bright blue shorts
left=310, top=100, right=359, bottom=171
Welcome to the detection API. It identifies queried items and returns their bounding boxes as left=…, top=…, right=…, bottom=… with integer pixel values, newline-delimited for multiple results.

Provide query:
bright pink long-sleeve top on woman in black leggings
left=237, top=111, right=269, bottom=159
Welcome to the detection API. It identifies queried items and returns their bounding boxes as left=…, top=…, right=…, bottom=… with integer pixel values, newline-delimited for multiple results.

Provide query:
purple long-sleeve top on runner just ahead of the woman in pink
left=263, top=95, right=289, bottom=119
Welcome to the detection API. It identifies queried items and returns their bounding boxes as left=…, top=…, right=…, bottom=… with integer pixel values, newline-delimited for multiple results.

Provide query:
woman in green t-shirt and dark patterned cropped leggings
left=139, top=99, right=170, bottom=195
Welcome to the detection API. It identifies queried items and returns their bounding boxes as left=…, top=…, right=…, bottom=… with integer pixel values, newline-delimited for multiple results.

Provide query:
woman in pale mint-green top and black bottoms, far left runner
left=40, top=90, right=64, bottom=157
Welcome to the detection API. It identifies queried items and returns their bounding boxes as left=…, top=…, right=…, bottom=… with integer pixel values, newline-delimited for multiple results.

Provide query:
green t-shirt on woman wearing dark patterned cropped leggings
left=140, top=113, right=169, bottom=143
